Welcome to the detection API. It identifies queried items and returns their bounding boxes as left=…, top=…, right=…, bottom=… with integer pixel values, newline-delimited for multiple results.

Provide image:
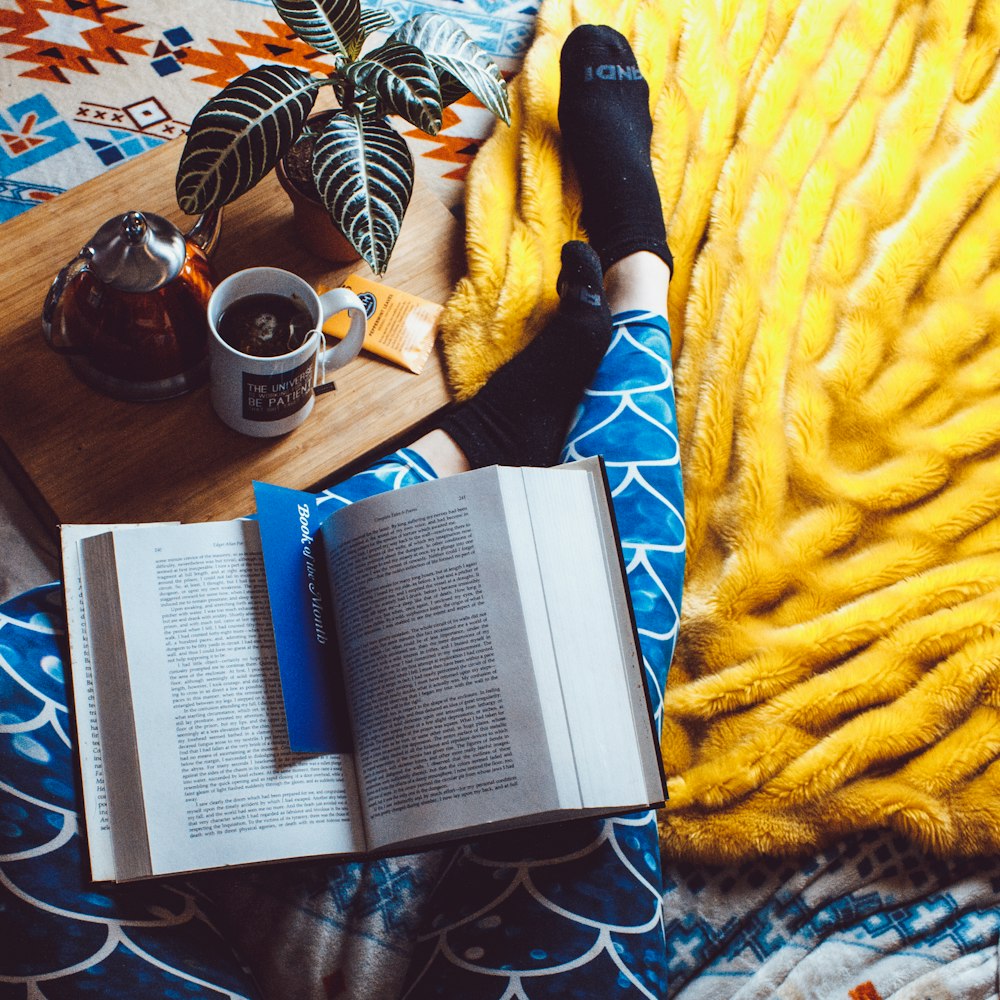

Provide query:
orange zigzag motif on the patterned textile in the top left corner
left=0, top=0, right=152, bottom=83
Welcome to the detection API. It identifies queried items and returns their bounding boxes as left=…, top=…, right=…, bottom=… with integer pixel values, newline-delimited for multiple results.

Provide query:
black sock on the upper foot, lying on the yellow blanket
left=559, top=24, right=674, bottom=272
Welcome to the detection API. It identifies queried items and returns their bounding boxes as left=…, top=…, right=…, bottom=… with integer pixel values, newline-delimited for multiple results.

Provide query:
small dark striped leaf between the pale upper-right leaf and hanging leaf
left=344, top=42, right=441, bottom=135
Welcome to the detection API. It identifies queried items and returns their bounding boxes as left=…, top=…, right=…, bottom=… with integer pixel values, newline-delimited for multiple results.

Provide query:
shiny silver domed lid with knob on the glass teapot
left=89, top=212, right=187, bottom=292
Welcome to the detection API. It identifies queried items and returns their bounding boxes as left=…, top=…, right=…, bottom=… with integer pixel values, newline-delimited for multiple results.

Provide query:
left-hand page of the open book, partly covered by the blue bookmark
left=103, top=521, right=364, bottom=873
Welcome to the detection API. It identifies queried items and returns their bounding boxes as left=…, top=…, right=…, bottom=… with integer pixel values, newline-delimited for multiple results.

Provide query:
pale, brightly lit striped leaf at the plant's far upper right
left=387, top=11, right=510, bottom=125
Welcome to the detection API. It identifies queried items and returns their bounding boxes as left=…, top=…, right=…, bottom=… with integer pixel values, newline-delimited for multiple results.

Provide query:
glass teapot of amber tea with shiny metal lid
left=42, top=210, right=222, bottom=400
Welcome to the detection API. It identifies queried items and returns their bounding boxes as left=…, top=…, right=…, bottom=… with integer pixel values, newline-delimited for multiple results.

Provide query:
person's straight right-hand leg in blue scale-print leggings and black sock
left=405, top=26, right=684, bottom=1000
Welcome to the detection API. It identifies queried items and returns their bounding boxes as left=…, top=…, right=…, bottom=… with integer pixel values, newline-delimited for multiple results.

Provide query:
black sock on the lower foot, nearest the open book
left=438, top=241, right=611, bottom=469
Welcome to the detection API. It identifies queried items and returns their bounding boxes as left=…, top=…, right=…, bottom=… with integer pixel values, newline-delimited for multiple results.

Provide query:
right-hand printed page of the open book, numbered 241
left=322, top=469, right=559, bottom=846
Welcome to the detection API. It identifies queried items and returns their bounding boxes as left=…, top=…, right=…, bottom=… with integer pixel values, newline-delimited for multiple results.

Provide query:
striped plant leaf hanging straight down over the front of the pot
left=313, top=112, right=413, bottom=274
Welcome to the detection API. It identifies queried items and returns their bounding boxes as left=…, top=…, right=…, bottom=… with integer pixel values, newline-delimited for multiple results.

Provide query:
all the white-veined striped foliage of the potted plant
left=176, top=0, right=510, bottom=274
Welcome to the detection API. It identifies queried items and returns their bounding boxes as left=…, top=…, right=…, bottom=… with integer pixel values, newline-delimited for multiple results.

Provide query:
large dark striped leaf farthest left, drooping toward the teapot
left=176, top=66, right=318, bottom=215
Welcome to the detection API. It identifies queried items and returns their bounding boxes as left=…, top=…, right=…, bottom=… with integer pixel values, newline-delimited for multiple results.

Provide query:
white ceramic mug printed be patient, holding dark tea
left=208, top=267, right=367, bottom=437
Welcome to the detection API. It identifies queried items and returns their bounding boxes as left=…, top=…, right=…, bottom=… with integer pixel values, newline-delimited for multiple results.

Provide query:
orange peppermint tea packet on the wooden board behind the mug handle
left=320, top=274, right=444, bottom=375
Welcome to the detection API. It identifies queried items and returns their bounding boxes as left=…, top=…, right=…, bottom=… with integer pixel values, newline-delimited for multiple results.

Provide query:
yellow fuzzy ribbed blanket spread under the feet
left=444, top=0, right=1000, bottom=861
